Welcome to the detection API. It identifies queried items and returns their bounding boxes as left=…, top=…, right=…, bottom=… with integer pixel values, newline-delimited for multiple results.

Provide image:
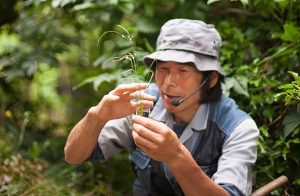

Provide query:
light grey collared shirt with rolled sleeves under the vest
left=98, top=99, right=259, bottom=195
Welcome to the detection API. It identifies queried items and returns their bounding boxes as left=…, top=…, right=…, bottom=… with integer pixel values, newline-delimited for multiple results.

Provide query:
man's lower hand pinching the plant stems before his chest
left=132, top=116, right=182, bottom=164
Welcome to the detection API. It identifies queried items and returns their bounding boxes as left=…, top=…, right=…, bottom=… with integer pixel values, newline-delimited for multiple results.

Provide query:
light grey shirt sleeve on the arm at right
left=212, top=119, right=259, bottom=195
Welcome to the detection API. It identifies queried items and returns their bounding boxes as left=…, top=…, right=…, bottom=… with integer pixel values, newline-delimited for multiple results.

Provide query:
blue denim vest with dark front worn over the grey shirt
left=131, top=84, right=250, bottom=196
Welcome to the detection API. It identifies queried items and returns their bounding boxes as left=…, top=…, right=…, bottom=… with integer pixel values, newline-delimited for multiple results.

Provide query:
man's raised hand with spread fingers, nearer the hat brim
left=94, top=83, right=156, bottom=121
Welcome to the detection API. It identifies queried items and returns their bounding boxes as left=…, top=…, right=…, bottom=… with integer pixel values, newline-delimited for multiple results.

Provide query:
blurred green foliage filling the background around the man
left=0, top=0, right=300, bottom=195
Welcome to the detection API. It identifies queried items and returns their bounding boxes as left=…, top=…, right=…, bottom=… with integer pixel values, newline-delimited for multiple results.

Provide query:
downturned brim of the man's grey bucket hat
left=144, top=50, right=226, bottom=76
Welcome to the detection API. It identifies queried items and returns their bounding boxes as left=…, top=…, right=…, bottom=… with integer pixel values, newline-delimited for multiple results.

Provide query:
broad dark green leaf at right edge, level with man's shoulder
left=282, top=112, right=300, bottom=137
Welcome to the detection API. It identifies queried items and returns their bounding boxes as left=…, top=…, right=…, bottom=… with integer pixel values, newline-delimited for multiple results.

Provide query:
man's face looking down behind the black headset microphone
left=155, top=61, right=203, bottom=113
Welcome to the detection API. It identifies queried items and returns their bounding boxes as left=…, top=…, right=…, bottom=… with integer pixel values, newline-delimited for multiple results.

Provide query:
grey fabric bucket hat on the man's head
left=144, top=19, right=225, bottom=76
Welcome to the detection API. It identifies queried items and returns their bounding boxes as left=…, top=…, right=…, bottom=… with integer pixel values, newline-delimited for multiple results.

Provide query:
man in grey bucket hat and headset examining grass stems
left=65, top=19, right=259, bottom=196
